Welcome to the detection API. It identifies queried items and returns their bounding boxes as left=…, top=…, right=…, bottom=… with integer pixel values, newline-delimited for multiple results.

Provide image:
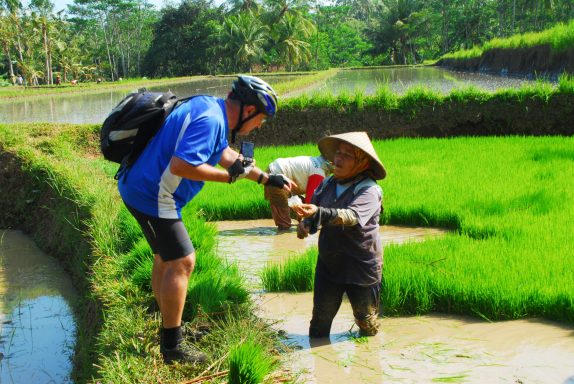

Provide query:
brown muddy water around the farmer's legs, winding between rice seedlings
left=217, top=220, right=574, bottom=384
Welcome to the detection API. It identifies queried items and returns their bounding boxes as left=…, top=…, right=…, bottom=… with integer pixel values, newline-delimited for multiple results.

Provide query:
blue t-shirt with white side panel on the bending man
left=118, top=96, right=229, bottom=219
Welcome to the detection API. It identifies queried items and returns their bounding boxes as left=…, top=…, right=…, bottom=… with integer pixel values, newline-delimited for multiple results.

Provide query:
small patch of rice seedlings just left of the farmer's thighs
left=260, top=248, right=317, bottom=292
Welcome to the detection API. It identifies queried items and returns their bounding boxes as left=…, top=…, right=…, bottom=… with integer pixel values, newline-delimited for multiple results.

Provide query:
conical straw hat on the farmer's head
left=319, top=132, right=387, bottom=180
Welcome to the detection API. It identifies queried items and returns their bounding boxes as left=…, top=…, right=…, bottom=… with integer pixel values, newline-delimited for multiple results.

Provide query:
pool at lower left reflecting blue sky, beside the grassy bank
left=0, top=230, right=77, bottom=384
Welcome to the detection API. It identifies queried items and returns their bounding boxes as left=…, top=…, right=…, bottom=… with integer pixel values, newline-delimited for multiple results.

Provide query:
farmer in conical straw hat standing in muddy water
left=293, top=132, right=387, bottom=337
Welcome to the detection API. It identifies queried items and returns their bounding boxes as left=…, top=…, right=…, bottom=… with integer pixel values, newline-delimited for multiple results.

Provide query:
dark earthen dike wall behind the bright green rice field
left=250, top=93, right=574, bottom=145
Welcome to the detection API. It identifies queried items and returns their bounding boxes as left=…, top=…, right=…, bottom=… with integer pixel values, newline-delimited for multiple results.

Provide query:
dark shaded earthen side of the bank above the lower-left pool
left=0, top=150, right=97, bottom=382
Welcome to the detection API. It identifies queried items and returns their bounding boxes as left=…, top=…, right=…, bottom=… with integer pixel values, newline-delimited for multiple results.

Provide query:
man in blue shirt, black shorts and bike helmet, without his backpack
left=118, top=76, right=296, bottom=364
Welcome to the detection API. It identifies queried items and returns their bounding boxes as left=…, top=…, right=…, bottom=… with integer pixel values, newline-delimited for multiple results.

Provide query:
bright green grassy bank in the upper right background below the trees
left=442, top=20, right=574, bottom=60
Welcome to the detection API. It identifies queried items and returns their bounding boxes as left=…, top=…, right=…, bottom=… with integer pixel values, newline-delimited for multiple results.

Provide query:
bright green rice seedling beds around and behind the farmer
left=194, top=137, right=574, bottom=323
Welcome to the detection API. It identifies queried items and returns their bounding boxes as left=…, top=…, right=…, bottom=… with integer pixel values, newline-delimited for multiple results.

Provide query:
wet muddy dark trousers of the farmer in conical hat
left=309, top=274, right=381, bottom=337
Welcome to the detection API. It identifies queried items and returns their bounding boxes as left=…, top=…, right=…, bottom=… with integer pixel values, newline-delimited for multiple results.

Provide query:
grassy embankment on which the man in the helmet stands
left=0, top=124, right=292, bottom=383
